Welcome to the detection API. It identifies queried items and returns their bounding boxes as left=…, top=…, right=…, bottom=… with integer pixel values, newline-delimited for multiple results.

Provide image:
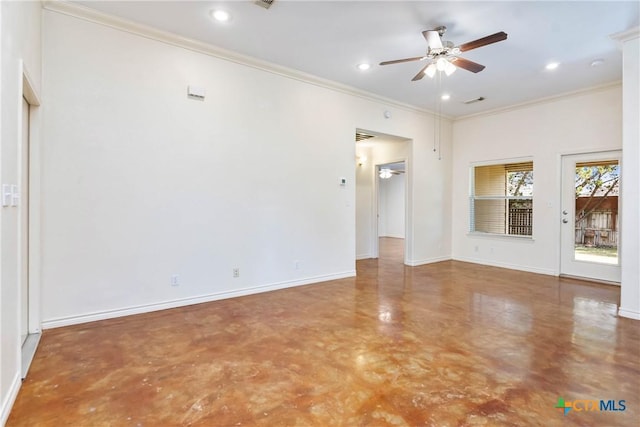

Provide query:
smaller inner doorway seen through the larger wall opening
left=376, top=161, right=406, bottom=263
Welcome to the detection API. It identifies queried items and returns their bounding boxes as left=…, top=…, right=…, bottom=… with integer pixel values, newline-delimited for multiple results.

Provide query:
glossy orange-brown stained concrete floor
left=7, top=239, right=640, bottom=426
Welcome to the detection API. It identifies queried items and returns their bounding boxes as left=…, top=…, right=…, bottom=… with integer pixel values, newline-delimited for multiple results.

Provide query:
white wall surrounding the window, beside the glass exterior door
left=452, top=85, right=622, bottom=274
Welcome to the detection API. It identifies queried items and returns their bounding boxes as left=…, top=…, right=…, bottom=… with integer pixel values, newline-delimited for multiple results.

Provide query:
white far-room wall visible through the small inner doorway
left=378, top=174, right=405, bottom=239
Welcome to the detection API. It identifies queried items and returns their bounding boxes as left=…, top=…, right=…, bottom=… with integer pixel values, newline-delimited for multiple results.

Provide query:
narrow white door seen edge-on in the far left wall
left=19, top=98, right=29, bottom=344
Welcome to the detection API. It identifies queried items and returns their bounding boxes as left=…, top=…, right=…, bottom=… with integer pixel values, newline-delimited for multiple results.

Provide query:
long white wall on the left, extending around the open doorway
left=42, top=5, right=449, bottom=327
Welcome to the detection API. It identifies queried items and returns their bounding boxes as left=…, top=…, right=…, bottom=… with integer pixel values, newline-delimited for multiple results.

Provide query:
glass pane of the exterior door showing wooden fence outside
left=574, top=160, right=620, bottom=265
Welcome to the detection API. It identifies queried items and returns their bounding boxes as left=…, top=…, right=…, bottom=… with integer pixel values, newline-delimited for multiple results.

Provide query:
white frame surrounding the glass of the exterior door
left=558, top=149, right=624, bottom=286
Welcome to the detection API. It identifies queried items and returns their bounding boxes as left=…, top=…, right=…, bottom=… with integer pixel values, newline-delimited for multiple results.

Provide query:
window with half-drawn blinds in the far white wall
left=470, top=162, right=533, bottom=236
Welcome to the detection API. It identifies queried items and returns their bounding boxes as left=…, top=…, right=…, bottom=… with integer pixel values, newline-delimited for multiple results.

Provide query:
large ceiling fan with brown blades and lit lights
left=380, top=26, right=507, bottom=82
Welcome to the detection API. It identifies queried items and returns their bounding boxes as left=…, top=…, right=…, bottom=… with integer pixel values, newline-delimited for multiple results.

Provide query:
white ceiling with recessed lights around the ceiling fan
left=72, top=0, right=640, bottom=117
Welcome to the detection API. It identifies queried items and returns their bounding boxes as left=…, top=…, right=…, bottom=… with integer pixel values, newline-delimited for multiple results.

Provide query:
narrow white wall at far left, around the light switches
left=0, top=1, right=41, bottom=424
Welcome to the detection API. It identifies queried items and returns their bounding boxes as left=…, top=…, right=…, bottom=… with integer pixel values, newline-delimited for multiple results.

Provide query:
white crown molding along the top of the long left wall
left=42, top=0, right=438, bottom=119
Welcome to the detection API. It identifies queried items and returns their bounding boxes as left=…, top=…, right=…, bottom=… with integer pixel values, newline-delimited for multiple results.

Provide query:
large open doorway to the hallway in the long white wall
left=356, top=129, right=412, bottom=264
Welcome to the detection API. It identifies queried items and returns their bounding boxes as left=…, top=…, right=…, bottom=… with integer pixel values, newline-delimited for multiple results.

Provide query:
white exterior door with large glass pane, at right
left=560, top=151, right=622, bottom=283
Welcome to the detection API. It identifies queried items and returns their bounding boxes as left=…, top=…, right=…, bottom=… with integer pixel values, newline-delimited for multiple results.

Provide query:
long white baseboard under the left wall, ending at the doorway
left=42, top=270, right=356, bottom=329
